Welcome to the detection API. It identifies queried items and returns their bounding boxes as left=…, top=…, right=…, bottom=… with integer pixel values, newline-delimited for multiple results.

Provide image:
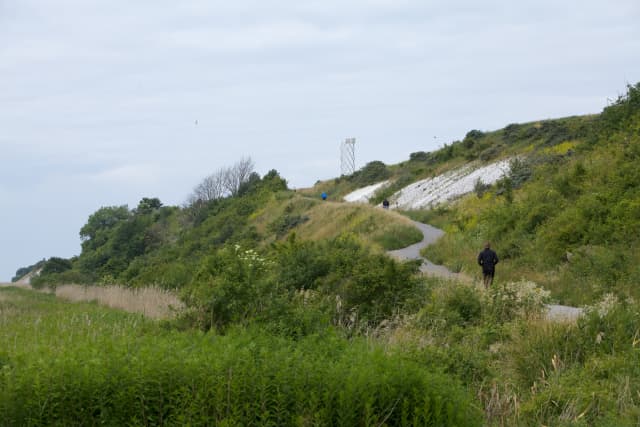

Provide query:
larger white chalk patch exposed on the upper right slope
left=391, top=159, right=510, bottom=209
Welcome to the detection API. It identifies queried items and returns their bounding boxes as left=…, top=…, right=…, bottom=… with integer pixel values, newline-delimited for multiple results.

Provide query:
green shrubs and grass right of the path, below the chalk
left=426, top=85, right=640, bottom=305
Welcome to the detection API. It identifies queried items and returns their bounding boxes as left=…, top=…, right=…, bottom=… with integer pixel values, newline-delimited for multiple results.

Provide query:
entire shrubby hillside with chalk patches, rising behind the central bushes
left=15, top=81, right=640, bottom=305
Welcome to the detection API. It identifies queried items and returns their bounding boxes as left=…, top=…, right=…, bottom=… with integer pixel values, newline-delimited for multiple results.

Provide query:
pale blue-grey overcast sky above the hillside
left=0, top=0, right=640, bottom=281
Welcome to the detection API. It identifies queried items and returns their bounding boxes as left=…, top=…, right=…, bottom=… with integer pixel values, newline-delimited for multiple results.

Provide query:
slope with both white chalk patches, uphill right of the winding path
left=308, top=85, right=640, bottom=305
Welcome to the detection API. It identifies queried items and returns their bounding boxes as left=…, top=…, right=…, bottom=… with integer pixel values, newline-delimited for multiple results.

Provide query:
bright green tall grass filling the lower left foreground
left=0, top=289, right=481, bottom=426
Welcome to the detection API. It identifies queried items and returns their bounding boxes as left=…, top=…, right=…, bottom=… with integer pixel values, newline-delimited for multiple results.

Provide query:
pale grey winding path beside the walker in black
left=389, top=221, right=583, bottom=320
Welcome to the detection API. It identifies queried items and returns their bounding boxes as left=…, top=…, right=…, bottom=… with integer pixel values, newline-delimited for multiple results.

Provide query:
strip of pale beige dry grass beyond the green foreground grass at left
left=56, top=285, right=184, bottom=319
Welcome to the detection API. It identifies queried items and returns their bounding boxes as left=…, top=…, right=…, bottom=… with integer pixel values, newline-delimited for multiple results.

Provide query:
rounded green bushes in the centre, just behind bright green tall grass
left=184, top=236, right=418, bottom=334
